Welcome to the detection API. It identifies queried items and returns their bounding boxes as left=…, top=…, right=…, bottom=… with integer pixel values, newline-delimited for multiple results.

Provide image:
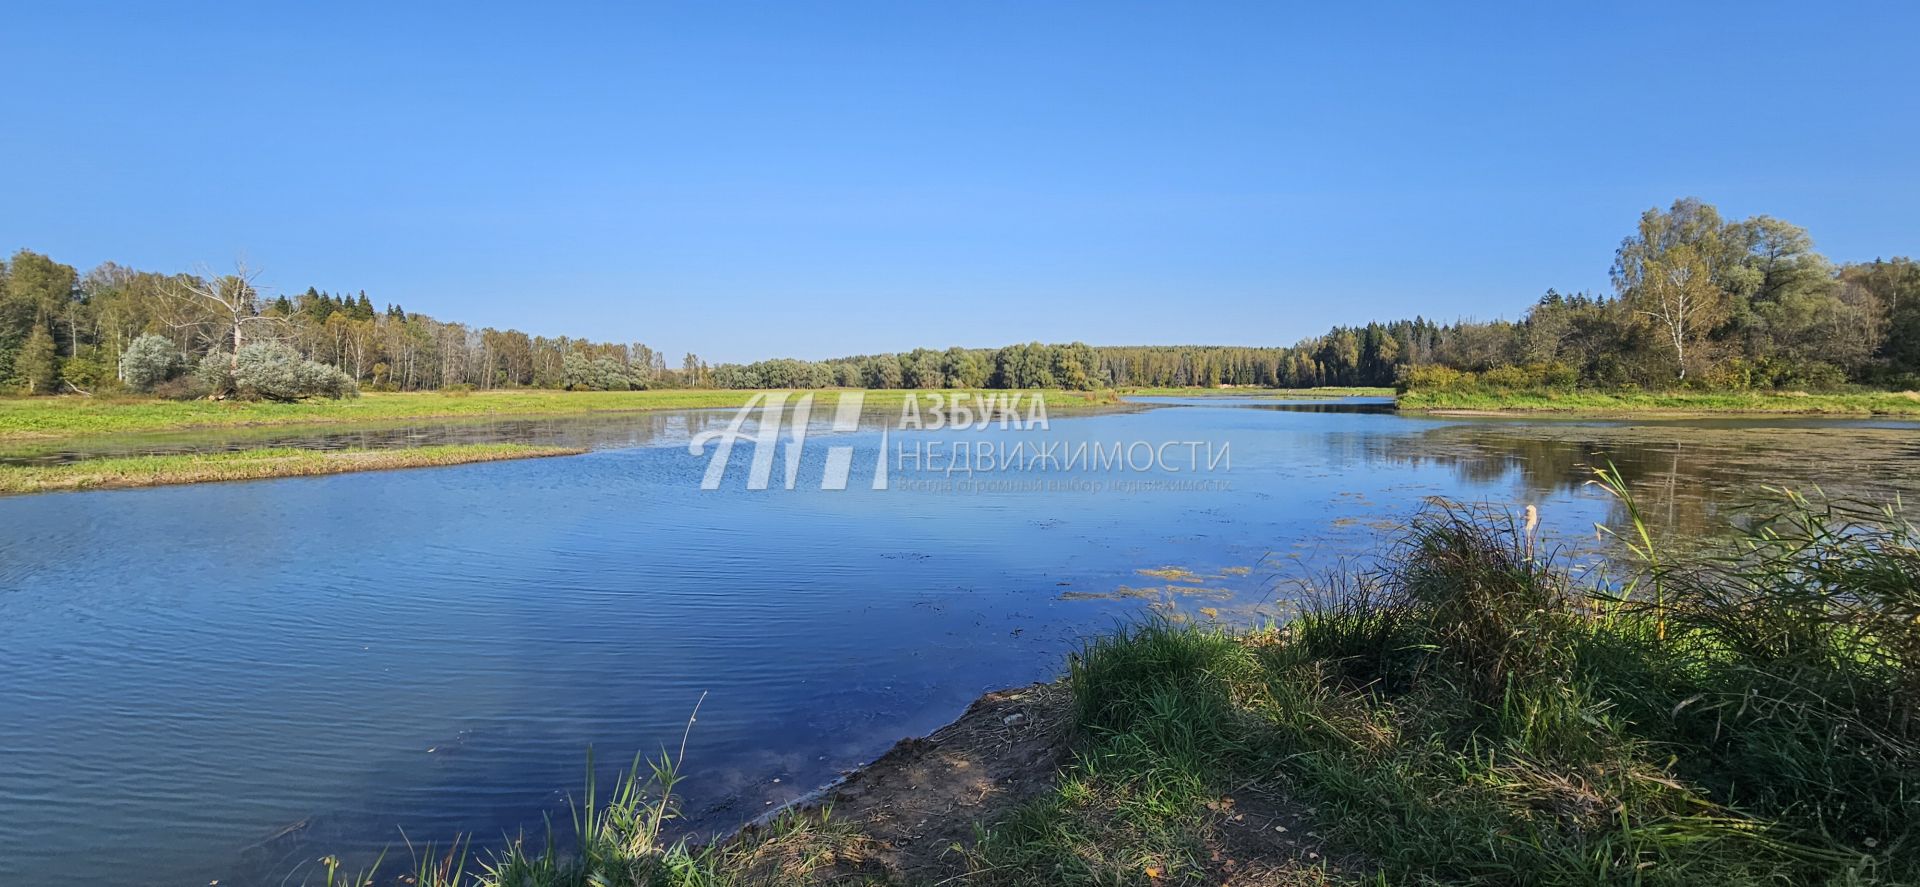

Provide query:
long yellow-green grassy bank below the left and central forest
left=0, top=390, right=1114, bottom=440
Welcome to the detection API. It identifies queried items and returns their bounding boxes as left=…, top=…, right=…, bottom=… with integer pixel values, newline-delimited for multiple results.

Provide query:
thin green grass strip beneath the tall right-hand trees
left=1398, top=390, right=1920, bottom=417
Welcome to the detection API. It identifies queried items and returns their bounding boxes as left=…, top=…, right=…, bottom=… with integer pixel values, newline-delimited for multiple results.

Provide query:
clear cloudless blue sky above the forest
left=0, top=2, right=1920, bottom=361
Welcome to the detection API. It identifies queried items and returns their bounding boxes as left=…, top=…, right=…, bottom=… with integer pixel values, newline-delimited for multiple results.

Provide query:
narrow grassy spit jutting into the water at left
left=0, top=444, right=582, bottom=493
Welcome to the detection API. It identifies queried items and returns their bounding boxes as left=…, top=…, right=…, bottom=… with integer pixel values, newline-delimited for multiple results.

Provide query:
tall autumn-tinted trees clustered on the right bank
left=1443, top=198, right=1920, bottom=390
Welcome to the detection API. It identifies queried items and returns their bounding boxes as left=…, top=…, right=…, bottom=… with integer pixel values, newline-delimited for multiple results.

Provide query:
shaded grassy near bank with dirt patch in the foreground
left=334, top=481, right=1920, bottom=887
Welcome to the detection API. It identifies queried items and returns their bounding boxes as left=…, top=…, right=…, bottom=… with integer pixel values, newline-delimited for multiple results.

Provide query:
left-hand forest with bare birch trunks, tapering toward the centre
left=0, top=259, right=701, bottom=396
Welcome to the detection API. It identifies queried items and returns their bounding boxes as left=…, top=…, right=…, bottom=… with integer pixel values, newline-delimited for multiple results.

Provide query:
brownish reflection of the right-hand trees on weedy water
left=1365, top=422, right=1920, bottom=538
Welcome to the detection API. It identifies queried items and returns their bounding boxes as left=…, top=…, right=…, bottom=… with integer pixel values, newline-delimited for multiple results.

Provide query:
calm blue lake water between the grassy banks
left=0, top=399, right=1920, bottom=885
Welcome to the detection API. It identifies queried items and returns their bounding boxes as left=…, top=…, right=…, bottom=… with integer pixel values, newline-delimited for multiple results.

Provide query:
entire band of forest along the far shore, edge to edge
left=0, top=200, right=1920, bottom=399
